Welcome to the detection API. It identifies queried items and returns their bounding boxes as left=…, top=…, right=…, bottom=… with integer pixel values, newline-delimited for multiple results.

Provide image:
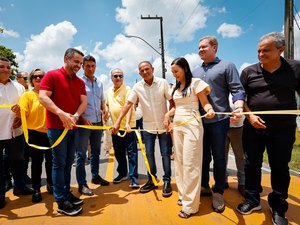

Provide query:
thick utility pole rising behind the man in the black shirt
left=284, top=0, right=294, bottom=59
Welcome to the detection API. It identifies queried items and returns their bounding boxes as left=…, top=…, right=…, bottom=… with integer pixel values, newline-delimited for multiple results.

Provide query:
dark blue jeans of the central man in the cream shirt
left=144, top=131, right=171, bottom=182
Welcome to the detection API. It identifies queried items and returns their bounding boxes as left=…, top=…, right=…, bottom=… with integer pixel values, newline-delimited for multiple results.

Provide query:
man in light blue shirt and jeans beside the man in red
left=76, top=55, right=109, bottom=196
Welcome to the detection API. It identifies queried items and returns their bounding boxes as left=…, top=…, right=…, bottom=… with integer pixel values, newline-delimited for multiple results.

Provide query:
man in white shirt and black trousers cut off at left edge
left=0, top=57, right=33, bottom=209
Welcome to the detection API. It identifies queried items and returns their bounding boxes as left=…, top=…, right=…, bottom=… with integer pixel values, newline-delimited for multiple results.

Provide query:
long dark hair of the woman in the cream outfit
left=171, top=57, right=193, bottom=97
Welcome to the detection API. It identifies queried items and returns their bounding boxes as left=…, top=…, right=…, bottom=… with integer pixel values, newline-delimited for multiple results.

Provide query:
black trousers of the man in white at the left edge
left=0, top=135, right=25, bottom=197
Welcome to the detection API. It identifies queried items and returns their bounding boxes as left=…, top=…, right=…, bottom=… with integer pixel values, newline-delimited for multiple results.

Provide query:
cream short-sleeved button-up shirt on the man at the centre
left=127, top=77, right=172, bottom=134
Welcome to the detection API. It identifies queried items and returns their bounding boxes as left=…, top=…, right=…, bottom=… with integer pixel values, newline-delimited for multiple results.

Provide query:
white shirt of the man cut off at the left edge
left=0, top=80, right=25, bottom=140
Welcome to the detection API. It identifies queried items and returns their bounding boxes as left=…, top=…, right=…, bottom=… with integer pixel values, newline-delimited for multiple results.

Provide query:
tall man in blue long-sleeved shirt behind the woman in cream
left=193, top=36, right=245, bottom=213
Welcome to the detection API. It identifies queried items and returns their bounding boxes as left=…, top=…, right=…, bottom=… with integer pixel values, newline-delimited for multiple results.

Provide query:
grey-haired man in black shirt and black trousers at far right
left=237, top=32, right=300, bottom=224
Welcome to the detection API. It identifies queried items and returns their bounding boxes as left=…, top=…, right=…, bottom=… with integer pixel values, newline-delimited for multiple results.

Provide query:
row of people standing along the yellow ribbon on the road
left=0, top=32, right=300, bottom=224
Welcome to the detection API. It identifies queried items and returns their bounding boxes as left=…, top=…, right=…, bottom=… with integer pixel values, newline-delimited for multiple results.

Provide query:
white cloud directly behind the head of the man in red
left=18, top=21, right=77, bottom=71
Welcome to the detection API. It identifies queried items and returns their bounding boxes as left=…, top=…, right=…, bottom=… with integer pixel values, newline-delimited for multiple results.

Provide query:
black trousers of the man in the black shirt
left=243, top=121, right=295, bottom=213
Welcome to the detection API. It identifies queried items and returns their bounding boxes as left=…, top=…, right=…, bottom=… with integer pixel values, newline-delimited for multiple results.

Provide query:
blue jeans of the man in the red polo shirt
left=48, top=129, right=78, bottom=203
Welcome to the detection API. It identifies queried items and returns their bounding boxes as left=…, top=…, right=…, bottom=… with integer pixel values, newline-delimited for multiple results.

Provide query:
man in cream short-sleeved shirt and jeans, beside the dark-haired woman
left=112, top=61, right=174, bottom=197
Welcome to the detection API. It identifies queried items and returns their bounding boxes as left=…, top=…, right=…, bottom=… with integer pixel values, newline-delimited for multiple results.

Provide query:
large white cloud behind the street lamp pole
left=97, top=0, right=209, bottom=83
